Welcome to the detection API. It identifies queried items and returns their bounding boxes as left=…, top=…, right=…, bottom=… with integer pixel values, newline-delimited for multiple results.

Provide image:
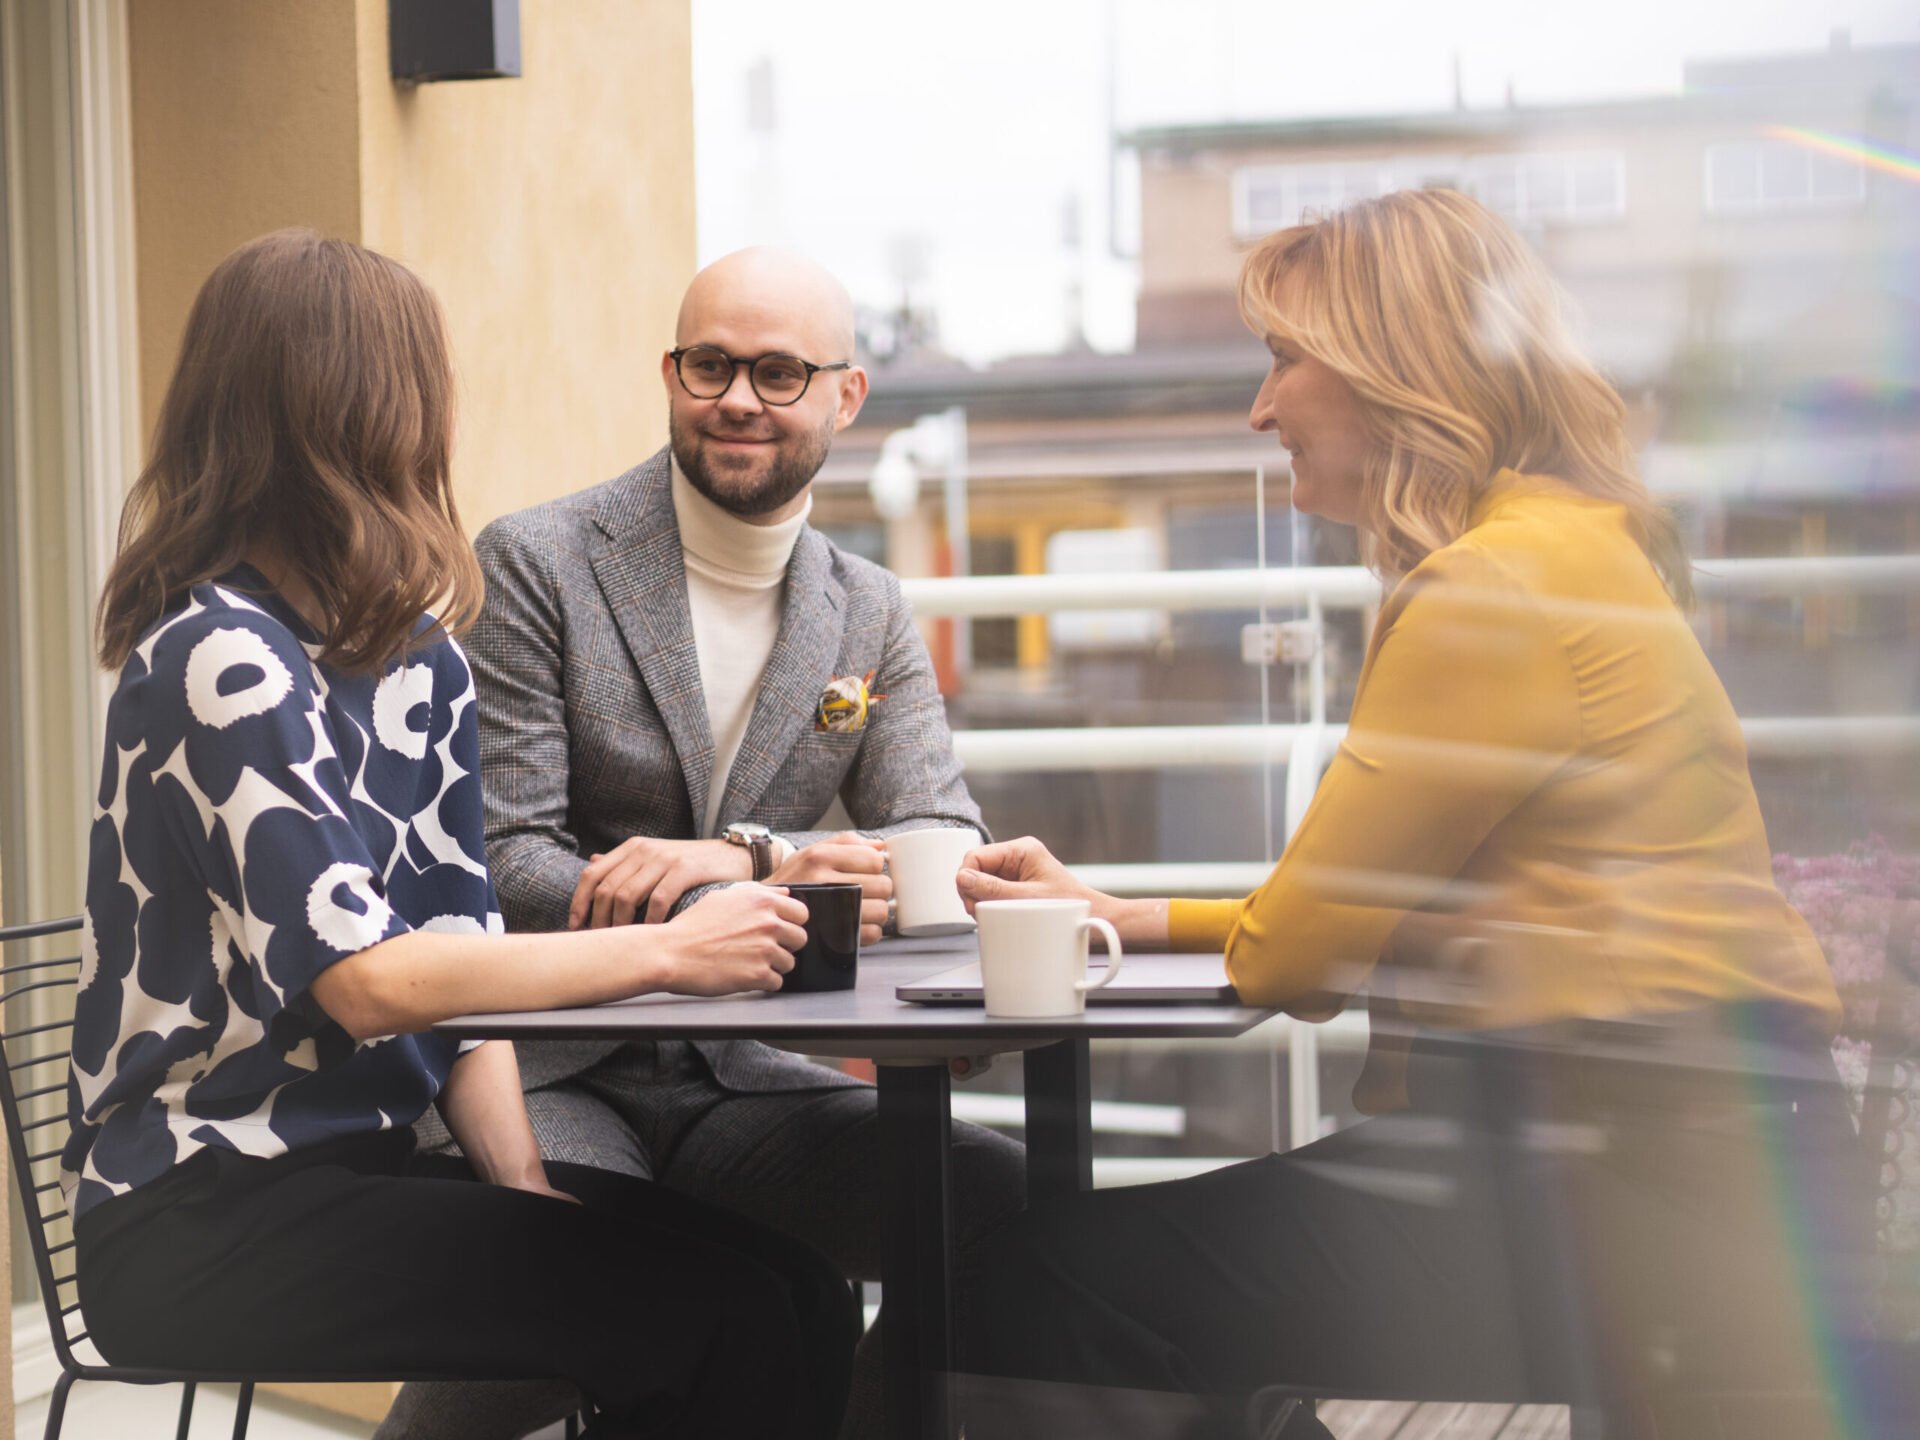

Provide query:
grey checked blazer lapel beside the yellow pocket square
left=720, top=526, right=847, bottom=822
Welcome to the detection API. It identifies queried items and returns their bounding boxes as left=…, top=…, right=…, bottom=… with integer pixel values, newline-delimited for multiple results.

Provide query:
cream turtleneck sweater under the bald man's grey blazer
left=674, top=461, right=814, bottom=844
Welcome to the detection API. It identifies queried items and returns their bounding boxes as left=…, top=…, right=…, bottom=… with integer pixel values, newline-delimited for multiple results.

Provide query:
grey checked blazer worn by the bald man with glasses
left=467, top=449, right=985, bottom=1091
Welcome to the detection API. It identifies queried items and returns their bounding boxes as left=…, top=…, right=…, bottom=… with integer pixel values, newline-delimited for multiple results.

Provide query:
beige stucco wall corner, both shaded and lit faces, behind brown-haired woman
left=131, top=0, right=695, bottom=530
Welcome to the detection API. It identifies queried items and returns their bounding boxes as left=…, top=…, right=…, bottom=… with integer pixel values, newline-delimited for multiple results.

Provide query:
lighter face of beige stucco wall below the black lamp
left=359, top=0, right=693, bottom=528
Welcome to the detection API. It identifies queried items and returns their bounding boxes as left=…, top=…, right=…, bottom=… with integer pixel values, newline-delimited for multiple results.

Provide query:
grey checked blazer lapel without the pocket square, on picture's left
left=593, top=449, right=714, bottom=824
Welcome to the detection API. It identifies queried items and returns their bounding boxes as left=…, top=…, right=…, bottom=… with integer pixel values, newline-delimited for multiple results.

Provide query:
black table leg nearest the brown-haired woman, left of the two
left=876, top=1062, right=954, bottom=1440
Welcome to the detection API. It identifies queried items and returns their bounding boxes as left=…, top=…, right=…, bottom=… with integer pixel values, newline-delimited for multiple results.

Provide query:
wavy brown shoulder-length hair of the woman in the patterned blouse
left=96, top=230, right=482, bottom=672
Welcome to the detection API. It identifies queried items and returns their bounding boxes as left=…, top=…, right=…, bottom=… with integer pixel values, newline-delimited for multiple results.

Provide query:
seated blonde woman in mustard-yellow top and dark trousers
left=960, top=190, right=1851, bottom=1434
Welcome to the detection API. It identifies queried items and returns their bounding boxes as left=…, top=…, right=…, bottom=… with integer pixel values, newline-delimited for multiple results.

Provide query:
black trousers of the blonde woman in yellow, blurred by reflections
left=958, top=1013, right=1866, bottom=1436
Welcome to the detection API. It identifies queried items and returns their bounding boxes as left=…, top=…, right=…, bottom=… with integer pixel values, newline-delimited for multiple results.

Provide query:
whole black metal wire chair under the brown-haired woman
left=0, top=916, right=580, bottom=1440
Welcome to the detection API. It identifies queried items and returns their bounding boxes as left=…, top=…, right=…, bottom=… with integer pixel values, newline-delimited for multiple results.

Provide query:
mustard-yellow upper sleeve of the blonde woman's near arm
left=1221, top=540, right=1580, bottom=1012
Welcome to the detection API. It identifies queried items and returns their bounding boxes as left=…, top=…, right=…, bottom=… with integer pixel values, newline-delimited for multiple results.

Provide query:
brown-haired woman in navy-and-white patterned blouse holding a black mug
left=61, top=230, right=858, bottom=1436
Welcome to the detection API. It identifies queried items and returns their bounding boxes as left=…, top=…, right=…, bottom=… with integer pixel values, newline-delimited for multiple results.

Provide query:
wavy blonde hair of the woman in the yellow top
left=1240, top=190, right=1693, bottom=607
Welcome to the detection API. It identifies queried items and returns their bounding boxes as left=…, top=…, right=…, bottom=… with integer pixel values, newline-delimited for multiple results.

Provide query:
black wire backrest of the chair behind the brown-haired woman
left=0, top=916, right=86, bottom=1369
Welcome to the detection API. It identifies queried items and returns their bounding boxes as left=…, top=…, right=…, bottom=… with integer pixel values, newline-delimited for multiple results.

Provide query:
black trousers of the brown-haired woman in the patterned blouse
left=77, top=1131, right=860, bottom=1440
